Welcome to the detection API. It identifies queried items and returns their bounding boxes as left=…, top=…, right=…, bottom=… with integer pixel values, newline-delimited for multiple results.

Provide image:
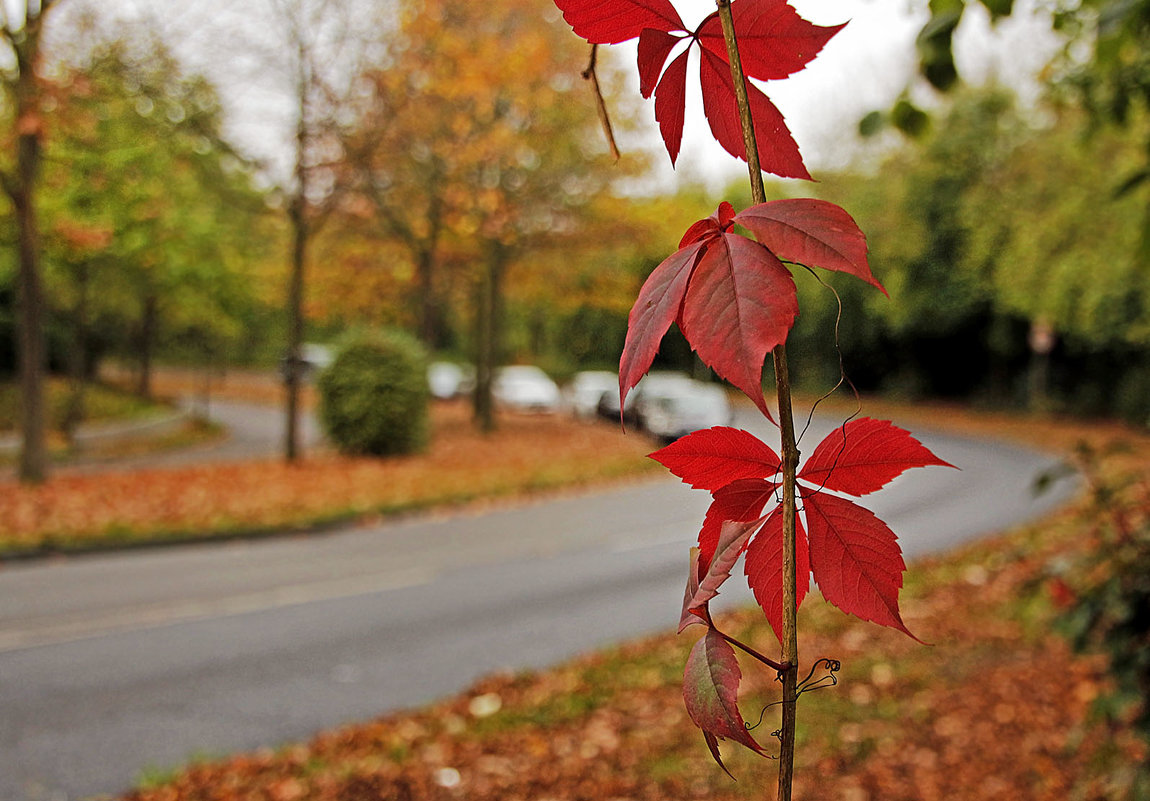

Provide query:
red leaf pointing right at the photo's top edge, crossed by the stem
left=698, top=0, right=845, bottom=80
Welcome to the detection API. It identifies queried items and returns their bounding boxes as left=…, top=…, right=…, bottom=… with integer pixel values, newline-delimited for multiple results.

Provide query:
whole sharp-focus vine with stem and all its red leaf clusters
left=555, top=0, right=948, bottom=800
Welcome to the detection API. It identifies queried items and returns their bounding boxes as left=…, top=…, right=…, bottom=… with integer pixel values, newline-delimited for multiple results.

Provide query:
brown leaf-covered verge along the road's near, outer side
left=124, top=407, right=1150, bottom=801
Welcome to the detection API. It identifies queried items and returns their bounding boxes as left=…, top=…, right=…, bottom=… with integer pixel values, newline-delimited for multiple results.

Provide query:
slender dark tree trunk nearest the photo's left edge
left=0, top=0, right=58, bottom=483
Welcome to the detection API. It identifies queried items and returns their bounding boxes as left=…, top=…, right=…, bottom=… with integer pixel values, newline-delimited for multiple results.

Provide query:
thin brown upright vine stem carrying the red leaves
left=715, top=0, right=798, bottom=801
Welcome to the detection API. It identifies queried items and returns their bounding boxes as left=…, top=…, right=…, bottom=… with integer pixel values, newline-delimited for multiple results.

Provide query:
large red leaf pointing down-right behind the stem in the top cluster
left=699, top=49, right=811, bottom=180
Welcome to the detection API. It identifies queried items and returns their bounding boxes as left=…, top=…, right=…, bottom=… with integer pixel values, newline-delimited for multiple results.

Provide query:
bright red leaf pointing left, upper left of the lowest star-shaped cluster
left=651, top=425, right=781, bottom=489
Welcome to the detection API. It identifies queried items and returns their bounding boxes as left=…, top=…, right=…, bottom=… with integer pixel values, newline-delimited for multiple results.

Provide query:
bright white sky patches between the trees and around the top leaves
left=49, top=0, right=1053, bottom=190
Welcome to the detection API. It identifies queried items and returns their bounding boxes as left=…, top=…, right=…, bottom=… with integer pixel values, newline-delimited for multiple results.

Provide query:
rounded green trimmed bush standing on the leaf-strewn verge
left=317, top=331, right=430, bottom=456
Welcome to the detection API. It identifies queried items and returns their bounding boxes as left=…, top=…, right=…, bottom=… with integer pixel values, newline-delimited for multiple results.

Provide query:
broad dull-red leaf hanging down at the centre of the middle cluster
left=676, top=233, right=798, bottom=419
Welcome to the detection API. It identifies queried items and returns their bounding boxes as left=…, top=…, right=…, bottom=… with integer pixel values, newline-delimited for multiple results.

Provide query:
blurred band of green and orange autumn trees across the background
left=0, top=0, right=1150, bottom=478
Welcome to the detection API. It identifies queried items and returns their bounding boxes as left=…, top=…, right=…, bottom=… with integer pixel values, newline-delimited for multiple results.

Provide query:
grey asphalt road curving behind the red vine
left=0, top=409, right=1068, bottom=801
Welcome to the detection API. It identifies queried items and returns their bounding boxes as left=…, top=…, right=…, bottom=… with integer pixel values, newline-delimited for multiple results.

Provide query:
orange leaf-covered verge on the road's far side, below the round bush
left=0, top=405, right=658, bottom=559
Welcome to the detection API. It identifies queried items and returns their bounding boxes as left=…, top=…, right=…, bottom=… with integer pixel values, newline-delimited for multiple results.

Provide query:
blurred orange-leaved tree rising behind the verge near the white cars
left=338, top=0, right=638, bottom=429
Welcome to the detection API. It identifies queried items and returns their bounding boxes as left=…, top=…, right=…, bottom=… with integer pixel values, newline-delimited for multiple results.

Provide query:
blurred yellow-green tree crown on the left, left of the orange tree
left=44, top=31, right=268, bottom=402
